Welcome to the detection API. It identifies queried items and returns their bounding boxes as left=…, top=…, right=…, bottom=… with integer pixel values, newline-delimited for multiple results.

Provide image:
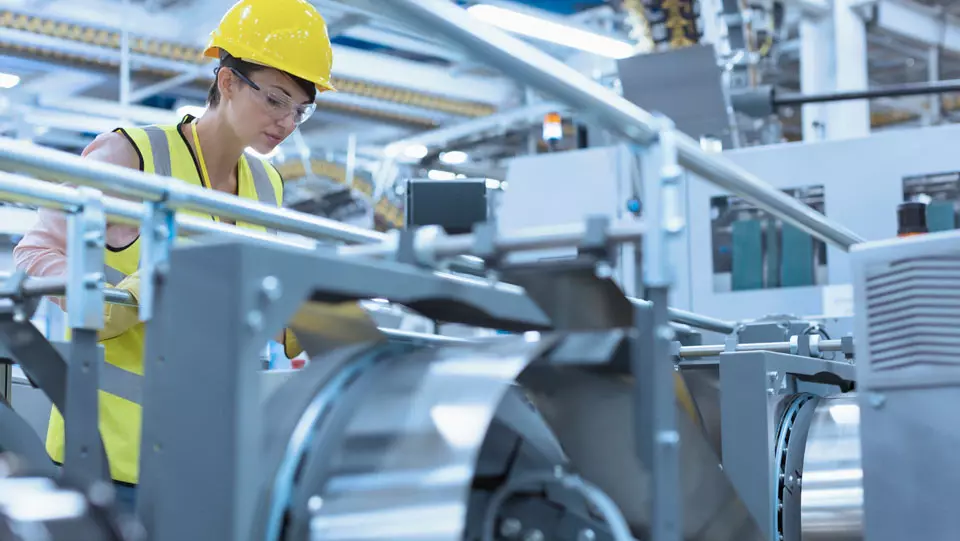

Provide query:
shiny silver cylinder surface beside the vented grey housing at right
left=800, top=395, right=868, bottom=541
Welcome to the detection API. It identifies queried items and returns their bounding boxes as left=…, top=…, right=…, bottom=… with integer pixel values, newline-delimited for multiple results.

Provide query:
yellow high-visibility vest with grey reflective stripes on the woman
left=46, top=115, right=283, bottom=484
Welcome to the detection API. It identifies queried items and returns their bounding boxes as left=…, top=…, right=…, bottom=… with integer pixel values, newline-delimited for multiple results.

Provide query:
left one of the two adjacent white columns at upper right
left=800, top=15, right=834, bottom=142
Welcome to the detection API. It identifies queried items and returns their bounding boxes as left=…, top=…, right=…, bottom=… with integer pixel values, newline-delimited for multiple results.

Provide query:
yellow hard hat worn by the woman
left=203, top=0, right=336, bottom=92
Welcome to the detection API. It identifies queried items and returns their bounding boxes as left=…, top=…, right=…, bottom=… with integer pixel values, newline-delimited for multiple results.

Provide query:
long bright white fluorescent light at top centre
left=467, top=4, right=636, bottom=60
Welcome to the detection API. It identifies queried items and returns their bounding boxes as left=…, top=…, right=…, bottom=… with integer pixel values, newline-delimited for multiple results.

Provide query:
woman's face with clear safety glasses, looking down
left=227, top=68, right=316, bottom=154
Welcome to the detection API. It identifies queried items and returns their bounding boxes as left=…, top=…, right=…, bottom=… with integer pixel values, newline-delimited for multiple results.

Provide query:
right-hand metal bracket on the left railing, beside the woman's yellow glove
left=140, top=201, right=177, bottom=322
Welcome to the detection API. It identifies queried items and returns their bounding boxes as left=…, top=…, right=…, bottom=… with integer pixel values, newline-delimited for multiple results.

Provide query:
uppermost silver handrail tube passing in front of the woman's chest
left=0, top=138, right=383, bottom=243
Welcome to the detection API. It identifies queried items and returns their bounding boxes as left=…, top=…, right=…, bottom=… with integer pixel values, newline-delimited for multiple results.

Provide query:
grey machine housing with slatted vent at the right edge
left=851, top=227, right=960, bottom=541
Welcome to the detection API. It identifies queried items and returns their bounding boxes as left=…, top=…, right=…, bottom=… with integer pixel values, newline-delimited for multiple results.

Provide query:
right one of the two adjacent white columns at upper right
left=827, top=0, right=870, bottom=139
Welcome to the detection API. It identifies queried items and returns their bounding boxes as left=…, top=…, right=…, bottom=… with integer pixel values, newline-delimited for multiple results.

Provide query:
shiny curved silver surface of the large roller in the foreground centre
left=311, top=338, right=556, bottom=541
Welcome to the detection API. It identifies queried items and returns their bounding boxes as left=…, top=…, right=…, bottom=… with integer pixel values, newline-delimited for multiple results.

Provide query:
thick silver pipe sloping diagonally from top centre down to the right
left=368, top=0, right=863, bottom=250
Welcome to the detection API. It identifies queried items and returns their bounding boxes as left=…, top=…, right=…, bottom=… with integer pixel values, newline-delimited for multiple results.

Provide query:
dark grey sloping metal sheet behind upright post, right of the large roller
left=520, top=367, right=763, bottom=541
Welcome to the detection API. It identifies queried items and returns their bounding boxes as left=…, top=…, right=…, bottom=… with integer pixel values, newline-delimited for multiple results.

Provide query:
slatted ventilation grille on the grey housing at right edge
left=866, top=256, right=960, bottom=375
